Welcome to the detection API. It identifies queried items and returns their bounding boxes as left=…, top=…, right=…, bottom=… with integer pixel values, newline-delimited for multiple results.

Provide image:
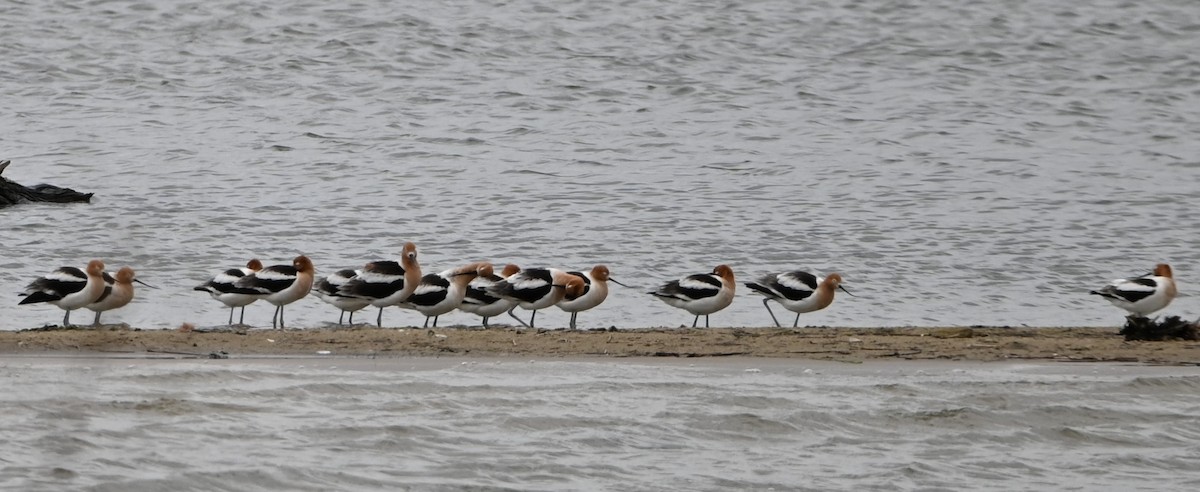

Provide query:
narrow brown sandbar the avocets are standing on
left=0, top=326, right=1200, bottom=365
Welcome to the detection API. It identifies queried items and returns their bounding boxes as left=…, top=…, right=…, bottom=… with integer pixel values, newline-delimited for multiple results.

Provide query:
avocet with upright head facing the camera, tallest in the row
left=338, top=242, right=421, bottom=326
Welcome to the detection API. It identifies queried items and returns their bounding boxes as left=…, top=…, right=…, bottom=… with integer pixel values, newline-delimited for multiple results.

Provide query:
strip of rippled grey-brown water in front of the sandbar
left=0, top=358, right=1200, bottom=491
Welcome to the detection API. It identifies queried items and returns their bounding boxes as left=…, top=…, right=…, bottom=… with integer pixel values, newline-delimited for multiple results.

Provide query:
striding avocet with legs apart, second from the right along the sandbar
left=745, top=270, right=854, bottom=328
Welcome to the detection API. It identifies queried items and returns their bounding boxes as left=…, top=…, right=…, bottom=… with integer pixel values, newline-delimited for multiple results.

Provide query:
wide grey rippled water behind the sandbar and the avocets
left=0, top=0, right=1200, bottom=329
